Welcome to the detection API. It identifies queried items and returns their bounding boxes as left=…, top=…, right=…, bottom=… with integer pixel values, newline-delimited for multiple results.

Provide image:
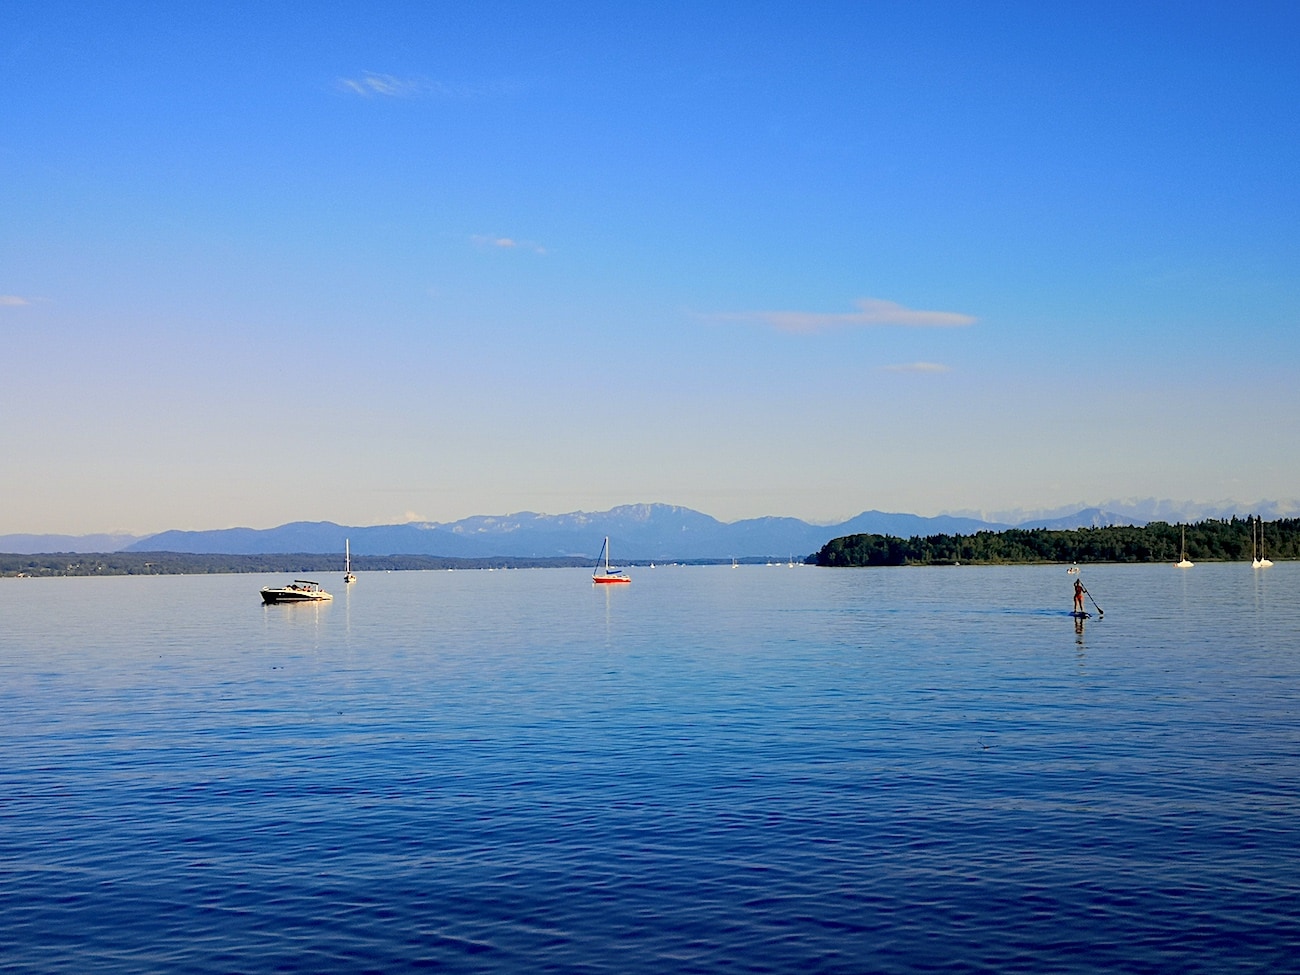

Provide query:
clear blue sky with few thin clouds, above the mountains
left=0, top=3, right=1300, bottom=533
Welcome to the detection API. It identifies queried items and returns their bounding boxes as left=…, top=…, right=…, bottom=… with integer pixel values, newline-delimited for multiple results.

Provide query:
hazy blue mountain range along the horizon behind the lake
left=0, top=499, right=1297, bottom=562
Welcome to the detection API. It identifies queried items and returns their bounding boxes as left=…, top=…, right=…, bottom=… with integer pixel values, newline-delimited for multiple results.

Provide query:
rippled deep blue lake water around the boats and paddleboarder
left=0, top=563, right=1300, bottom=974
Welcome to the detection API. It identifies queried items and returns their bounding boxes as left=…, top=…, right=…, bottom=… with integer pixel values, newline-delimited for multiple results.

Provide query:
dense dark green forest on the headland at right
left=813, top=517, right=1300, bottom=567
